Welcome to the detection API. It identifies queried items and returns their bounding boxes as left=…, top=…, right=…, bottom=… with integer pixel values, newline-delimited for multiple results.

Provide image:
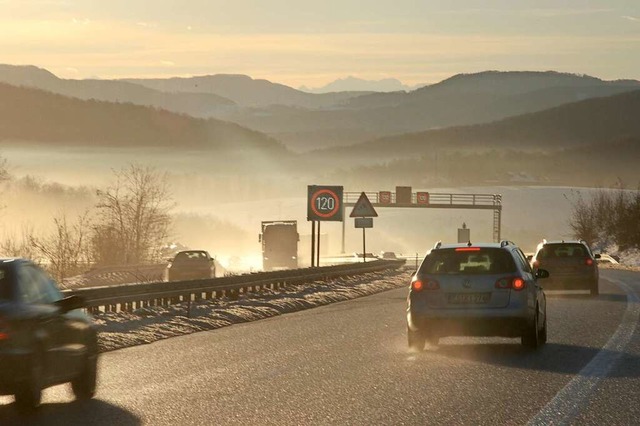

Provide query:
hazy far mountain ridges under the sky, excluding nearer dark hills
left=0, top=65, right=640, bottom=152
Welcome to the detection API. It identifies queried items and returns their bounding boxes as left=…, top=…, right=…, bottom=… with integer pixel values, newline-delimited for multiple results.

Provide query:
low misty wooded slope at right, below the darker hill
left=337, top=138, right=640, bottom=188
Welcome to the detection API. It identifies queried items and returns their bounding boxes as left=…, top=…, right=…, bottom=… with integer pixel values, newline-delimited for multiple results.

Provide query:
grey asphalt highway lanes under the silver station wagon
left=0, top=270, right=640, bottom=426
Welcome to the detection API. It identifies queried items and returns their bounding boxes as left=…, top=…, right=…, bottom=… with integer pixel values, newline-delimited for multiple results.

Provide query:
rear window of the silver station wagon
left=420, top=248, right=516, bottom=275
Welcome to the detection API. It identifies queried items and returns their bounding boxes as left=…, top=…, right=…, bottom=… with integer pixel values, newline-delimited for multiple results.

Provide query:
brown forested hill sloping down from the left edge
left=0, top=83, right=288, bottom=156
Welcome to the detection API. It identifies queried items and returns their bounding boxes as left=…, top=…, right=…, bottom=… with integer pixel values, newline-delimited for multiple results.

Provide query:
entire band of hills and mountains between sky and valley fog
left=0, top=65, right=640, bottom=183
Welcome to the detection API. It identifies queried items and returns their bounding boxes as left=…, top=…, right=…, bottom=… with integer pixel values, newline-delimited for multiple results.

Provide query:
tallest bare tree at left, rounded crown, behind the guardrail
left=93, top=164, right=174, bottom=265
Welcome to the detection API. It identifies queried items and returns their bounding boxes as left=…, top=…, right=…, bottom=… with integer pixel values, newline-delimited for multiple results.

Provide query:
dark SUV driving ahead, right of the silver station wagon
left=532, top=240, right=600, bottom=296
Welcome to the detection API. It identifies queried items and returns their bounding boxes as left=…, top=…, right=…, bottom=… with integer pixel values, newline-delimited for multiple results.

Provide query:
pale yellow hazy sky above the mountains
left=0, top=0, right=640, bottom=87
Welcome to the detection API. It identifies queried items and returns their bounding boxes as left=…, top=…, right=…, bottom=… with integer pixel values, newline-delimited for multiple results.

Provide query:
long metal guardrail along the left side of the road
left=63, top=260, right=404, bottom=314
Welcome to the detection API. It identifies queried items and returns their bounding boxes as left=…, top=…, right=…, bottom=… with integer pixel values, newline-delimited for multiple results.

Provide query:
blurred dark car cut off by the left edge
left=0, top=259, right=98, bottom=411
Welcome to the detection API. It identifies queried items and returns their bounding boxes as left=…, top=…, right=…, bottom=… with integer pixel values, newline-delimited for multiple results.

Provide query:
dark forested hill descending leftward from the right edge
left=322, top=91, right=640, bottom=157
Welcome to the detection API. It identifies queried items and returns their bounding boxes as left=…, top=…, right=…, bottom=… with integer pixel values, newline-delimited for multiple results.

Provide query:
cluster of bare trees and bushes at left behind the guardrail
left=0, top=164, right=174, bottom=282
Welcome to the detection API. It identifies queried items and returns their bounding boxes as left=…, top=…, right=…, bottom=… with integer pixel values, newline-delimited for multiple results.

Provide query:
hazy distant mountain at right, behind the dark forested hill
left=223, top=72, right=640, bottom=151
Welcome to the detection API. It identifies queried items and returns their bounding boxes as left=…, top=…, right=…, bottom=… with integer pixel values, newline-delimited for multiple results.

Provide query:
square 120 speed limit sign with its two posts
left=307, top=185, right=344, bottom=267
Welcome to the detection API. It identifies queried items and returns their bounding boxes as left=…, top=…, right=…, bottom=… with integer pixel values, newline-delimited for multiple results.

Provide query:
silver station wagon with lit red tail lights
left=407, top=241, right=549, bottom=350
